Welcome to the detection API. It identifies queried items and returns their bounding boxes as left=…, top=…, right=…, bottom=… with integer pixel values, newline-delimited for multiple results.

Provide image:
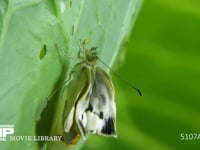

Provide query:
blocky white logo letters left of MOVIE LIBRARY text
left=0, top=125, right=14, bottom=141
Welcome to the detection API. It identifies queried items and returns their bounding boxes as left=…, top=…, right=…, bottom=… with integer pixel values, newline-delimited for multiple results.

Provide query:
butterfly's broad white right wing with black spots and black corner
left=85, top=67, right=117, bottom=137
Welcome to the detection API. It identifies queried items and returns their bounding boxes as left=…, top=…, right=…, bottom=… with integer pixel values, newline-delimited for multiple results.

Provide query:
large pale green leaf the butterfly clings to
left=0, top=0, right=141, bottom=149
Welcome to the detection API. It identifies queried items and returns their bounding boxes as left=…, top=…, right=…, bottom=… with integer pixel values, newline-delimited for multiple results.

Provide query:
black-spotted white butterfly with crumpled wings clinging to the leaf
left=63, top=47, right=117, bottom=144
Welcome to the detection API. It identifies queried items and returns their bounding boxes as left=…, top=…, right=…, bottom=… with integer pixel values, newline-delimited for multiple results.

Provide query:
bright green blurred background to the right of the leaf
left=83, top=0, right=200, bottom=150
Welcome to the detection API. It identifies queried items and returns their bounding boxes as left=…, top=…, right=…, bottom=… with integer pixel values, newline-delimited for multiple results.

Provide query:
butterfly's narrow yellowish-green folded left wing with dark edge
left=62, top=63, right=91, bottom=144
